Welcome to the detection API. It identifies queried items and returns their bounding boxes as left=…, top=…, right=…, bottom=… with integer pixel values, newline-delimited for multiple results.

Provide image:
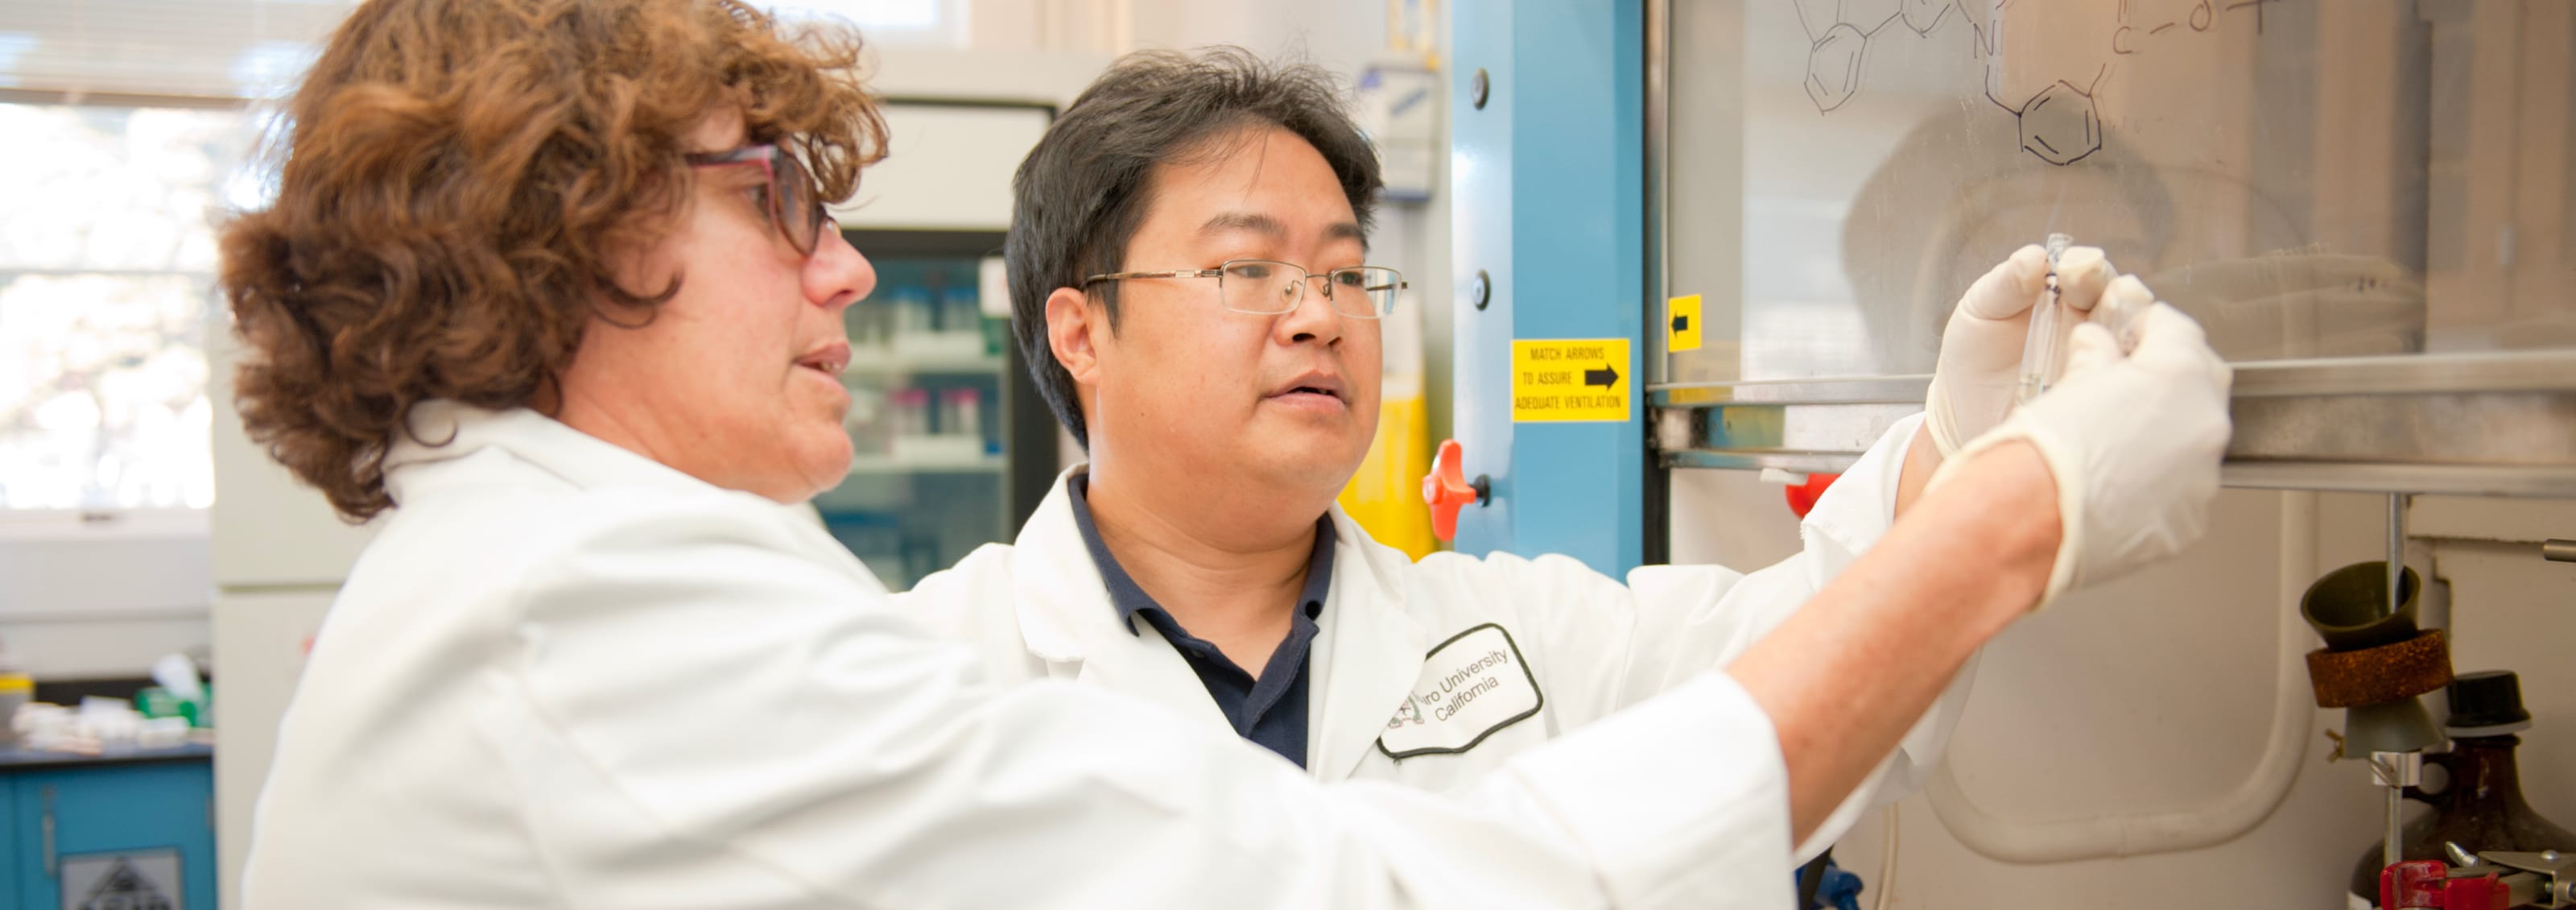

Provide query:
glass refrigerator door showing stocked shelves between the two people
left=814, top=230, right=1061, bottom=590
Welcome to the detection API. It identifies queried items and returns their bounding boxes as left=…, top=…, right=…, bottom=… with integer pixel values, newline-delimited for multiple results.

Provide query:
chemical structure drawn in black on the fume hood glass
left=1793, top=0, right=2282, bottom=168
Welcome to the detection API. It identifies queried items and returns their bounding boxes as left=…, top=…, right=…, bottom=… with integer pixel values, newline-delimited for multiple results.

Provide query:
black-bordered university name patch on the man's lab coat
left=1378, top=624, right=1546, bottom=758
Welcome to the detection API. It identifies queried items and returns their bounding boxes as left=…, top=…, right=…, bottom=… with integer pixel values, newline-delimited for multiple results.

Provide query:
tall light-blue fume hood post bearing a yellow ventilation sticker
left=1451, top=0, right=1646, bottom=575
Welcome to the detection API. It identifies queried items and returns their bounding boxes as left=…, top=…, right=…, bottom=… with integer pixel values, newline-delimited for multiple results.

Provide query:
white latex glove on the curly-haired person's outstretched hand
left=1932, top=297, right=2233, bottom=611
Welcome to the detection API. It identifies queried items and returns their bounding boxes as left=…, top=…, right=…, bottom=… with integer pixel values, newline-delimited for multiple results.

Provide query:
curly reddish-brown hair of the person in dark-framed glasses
left=219, top=0, right=886, bottom=521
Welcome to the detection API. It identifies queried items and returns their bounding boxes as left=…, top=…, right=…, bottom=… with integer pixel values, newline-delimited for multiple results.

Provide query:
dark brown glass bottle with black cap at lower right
left=2352, top=670, right=2576, bottom=902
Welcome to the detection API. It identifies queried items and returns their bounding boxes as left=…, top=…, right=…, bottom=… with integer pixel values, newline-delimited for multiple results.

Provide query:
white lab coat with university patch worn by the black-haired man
left=897, top=415, right=1971, bottom=855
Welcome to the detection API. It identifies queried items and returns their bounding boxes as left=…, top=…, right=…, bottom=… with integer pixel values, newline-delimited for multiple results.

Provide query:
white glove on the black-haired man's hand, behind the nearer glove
left=1924, top=245, right=2112, bottom=459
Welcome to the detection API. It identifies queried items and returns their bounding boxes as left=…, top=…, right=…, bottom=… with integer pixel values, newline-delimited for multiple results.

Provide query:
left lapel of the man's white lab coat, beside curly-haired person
left=1009, top=466, right=1234, bottom=734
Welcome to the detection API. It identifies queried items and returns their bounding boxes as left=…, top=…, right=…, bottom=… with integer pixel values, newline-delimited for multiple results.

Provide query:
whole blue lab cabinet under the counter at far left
left=0, top=758, right=214, bottom=910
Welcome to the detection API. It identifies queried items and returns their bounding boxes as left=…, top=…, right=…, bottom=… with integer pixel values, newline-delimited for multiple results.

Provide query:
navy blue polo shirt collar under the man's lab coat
left=1064, top=474, right=1335, bottom=768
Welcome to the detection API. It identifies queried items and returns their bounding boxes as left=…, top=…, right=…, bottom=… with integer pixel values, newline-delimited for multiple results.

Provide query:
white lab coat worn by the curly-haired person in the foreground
left=242, top=405, right=1834, bottom=910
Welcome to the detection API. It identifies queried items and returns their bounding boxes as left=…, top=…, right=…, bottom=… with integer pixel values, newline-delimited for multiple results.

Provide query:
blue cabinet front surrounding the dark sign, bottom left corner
left=8, top=763, right=214, bottom=910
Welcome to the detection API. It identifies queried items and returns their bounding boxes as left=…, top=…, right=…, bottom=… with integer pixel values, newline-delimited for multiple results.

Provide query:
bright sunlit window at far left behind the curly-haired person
left=0, top=103, right=255, bottom=511
